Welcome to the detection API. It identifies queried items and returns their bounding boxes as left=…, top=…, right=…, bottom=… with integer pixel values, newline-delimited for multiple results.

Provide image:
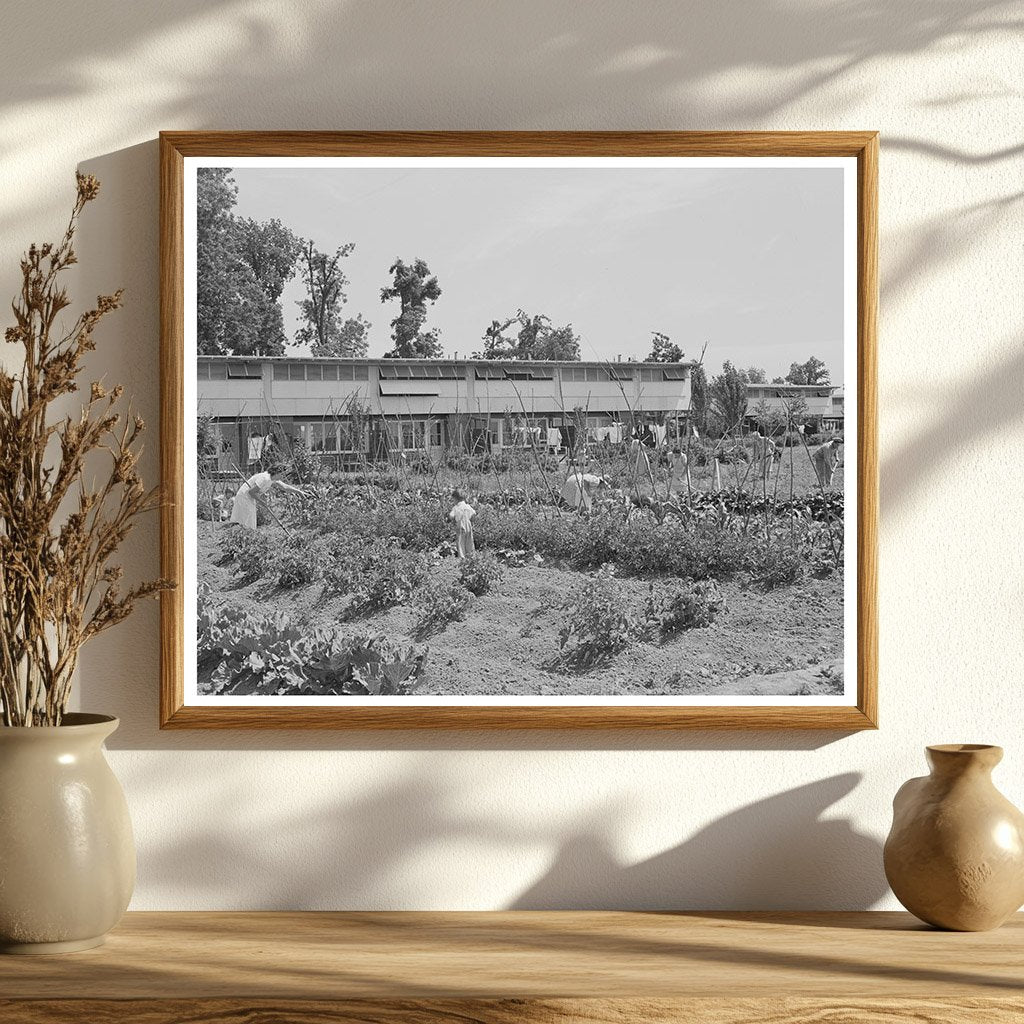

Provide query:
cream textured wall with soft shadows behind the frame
left=0, top=0, right=1024, bottom=908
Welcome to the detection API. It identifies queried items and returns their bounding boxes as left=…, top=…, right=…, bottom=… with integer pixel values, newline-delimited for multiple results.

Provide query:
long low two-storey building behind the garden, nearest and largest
left=197, top=355, right=693, bottom=469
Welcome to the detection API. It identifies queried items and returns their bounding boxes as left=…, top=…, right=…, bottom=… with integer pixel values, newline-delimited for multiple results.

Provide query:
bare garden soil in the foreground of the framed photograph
left=199, top=521, right=843, bottom=697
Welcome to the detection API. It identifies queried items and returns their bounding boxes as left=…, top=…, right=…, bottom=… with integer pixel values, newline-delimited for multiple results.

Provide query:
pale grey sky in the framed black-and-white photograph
left=232, top=167, right=843, bottom=383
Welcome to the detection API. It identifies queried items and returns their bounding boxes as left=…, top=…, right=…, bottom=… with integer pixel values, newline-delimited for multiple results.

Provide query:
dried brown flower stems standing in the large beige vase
left=0, top=174, right=170, bottom=726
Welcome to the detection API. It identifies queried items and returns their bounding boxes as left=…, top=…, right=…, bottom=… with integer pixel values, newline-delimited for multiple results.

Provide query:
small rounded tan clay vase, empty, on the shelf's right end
left=885, top=743, right=1024, bottom=932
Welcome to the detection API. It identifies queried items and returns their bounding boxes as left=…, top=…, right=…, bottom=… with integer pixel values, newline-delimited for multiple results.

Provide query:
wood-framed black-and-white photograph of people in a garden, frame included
left=161, top=132, right=878, bottom=730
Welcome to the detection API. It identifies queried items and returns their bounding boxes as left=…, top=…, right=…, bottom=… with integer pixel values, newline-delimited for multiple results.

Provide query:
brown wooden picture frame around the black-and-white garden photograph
left=160, top=131, right=879, bottom=730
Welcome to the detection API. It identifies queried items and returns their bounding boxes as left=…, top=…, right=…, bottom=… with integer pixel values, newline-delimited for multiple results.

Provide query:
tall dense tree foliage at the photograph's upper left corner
left=196, top=167, right=300, bottom=355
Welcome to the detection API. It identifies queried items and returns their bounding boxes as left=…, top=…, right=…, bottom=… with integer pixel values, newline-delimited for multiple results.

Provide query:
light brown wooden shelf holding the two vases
left=0, top=911, right=1024, bottom=1024
